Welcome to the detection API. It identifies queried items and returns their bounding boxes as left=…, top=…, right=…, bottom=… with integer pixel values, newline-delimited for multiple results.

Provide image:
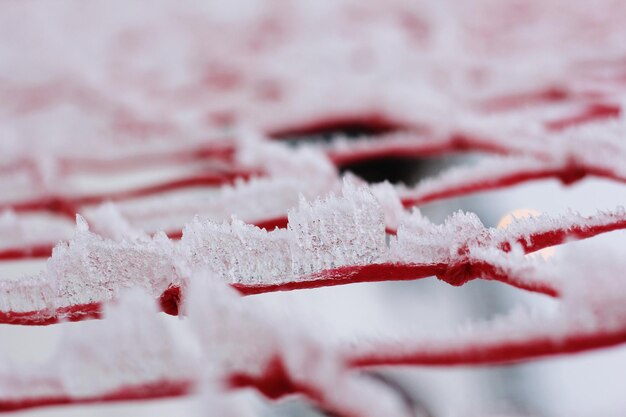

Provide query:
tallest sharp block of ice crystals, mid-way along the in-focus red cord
left=181, top=182, right=386, bottom=284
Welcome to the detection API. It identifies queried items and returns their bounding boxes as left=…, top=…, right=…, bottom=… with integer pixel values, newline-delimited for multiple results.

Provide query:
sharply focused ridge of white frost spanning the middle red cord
left=0, top=178, right=626, bottom=316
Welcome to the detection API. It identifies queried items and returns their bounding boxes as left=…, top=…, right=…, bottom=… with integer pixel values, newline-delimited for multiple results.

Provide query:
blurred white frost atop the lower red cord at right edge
left=350, top=245, right=626, bottom=361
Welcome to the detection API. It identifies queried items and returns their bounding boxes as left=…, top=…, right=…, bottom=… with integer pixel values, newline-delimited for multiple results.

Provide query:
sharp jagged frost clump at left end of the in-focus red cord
left=0, top=215, right=186, bottom=324
